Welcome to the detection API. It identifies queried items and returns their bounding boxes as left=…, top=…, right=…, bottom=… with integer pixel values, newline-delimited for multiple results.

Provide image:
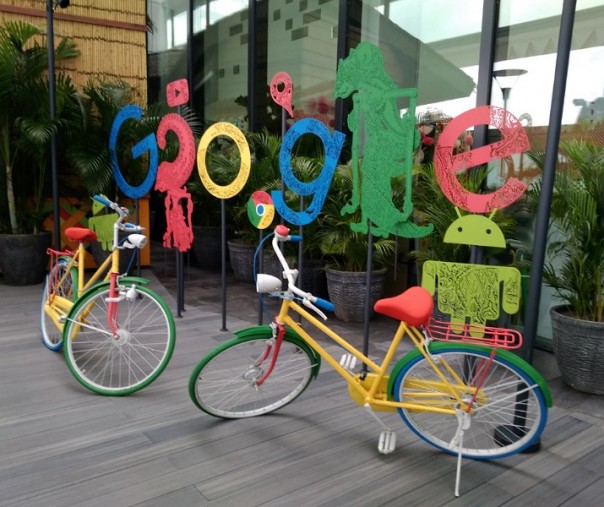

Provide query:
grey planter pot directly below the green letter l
left=326, top=268, right=386, bottom=322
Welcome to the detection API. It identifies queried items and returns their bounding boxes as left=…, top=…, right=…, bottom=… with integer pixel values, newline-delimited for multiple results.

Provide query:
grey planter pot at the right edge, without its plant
left=550, top=306, right=604, bottom=394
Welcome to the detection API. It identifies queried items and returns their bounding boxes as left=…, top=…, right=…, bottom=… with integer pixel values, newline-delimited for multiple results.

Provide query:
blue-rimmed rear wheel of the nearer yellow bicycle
left=393, top=345, right=547, bottom=459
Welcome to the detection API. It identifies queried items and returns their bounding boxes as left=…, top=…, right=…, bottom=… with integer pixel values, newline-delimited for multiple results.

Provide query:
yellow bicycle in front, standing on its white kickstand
left=189, top=225, right=552, bottom=494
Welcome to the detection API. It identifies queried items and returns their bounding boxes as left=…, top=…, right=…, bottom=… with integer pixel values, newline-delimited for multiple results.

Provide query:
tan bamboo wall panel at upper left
left=0, top=0, right=147, bottom=105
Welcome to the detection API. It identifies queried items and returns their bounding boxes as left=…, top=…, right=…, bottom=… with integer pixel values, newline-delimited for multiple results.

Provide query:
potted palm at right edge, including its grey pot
left=529, top=140, right=604, bottom=394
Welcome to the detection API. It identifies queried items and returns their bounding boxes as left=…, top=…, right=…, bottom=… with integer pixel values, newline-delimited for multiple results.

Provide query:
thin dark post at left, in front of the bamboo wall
left=46, top=0, right=69, bottom=250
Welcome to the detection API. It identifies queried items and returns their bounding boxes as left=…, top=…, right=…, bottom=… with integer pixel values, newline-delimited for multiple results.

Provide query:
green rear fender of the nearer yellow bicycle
left=388, top=342, right=554, bottom=408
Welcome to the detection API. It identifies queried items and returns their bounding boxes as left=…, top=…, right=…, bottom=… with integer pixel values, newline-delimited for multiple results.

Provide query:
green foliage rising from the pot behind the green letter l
left=315, top=164, right=396, bottom=271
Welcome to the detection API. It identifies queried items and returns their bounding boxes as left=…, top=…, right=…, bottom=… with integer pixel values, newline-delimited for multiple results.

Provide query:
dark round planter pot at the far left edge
left=0, top=231, right=52, bottom=285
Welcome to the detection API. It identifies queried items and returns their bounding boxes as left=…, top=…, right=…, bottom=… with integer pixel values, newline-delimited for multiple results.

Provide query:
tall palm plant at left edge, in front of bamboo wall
left=0, top=21, right=79, bottom=234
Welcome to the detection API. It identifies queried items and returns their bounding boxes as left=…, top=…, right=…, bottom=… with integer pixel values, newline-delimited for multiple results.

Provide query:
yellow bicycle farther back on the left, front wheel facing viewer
left=40, top=196, right=176, bottom=396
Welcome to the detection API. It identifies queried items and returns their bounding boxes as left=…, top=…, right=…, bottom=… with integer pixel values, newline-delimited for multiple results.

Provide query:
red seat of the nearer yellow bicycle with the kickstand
left=373, top=286, right=434, bottom=326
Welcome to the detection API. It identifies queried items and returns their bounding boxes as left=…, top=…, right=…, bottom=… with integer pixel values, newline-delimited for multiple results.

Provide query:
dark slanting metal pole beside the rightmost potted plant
left=520, top=0, right=577, bottom=363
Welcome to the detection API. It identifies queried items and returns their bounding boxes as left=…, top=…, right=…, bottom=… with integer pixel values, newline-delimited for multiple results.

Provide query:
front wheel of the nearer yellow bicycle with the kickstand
left=189, top=328, right=318, bottom=419
